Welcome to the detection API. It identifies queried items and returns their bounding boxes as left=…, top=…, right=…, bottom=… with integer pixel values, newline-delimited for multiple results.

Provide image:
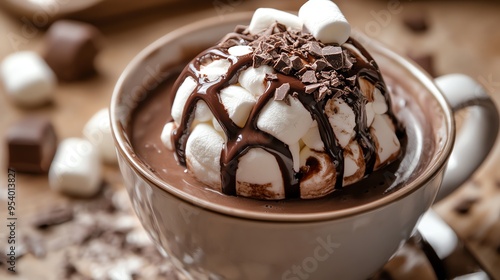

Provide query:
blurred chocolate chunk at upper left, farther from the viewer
left=44, top=20, right=101, bottom=81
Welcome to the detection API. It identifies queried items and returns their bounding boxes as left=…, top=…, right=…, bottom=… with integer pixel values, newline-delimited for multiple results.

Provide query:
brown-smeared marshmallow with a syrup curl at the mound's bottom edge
left=300, top=147, right=337, bottom=199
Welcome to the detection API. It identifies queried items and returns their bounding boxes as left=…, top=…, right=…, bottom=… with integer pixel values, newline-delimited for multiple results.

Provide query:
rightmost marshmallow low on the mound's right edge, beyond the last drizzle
left=371, top=114, right=400, bottom=168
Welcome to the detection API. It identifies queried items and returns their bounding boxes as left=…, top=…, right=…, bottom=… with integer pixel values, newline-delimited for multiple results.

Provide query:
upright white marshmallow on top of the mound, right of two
left=299, top=0, right=351, bottom=45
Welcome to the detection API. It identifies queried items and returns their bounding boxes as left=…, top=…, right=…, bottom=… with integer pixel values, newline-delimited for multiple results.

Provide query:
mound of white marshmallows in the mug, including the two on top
left=161, top=0, right=400, bottom=199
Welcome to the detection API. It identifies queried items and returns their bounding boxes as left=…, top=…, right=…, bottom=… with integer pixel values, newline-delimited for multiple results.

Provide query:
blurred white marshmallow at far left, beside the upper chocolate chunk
left=0, top=51, right=57, bottom=106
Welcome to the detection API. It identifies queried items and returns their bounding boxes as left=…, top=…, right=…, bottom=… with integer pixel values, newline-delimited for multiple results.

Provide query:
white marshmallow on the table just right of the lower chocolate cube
left=49, top=138, right=101, bottom=197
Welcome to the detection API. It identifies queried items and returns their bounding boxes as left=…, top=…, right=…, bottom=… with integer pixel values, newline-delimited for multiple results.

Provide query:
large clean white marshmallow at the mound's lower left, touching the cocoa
left=186, top=123, right=224, bottom=191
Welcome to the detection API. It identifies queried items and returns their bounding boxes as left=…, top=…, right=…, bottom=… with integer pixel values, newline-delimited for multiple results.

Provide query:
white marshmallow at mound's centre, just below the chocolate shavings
left=257, top=96, right=313, bottom=145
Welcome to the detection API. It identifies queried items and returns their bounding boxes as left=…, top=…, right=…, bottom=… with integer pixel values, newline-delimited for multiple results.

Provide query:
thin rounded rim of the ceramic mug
left=110, top=12, right=455, bottom=222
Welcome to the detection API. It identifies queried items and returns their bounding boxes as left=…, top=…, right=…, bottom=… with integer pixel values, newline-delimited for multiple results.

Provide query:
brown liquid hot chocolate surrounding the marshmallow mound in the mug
left=129, top=65, right=434, bottom=214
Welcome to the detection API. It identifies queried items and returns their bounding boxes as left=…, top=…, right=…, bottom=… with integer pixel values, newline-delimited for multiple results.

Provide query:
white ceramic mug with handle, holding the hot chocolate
left=111, top=13, right=498, bottom=280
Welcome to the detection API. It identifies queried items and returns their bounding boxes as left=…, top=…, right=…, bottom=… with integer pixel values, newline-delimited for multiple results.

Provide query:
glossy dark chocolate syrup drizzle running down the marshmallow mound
left=172, top=30, right=392, bottom=198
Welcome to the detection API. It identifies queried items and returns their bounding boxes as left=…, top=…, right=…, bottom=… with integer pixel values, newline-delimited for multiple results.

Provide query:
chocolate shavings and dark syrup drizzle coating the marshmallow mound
left=168, top=23, right=397, bottom=198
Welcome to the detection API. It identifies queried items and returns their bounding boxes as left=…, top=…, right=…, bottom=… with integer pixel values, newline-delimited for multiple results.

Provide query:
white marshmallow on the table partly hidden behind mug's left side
left=83, top=108, right=117, bottom=164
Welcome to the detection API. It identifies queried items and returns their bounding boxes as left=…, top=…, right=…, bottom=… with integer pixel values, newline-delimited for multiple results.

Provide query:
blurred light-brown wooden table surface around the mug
left=0, top=0, right=500, bottom=279
